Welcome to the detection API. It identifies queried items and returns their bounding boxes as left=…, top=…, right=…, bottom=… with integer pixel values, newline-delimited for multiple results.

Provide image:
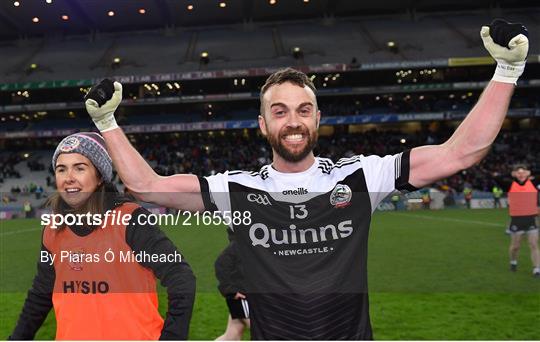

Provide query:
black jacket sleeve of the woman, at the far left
left=9, top=235, right=55, bottom=340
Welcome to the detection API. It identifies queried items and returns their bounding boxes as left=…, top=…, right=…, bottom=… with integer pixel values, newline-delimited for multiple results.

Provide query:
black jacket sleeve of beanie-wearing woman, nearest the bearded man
left=126, top=208, right=195, bottom=340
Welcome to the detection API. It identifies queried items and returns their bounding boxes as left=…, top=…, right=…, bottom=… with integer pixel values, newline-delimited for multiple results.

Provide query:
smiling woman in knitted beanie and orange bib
left=10, top=133, right=195, bottom=340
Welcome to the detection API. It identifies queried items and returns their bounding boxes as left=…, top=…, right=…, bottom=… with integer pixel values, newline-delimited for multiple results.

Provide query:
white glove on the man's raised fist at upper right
left=480, top=21, right=529, bottom=84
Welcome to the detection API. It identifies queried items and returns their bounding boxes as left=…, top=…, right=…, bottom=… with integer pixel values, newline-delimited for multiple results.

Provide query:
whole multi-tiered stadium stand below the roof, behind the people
left=0, top=4, right=540, bottom=216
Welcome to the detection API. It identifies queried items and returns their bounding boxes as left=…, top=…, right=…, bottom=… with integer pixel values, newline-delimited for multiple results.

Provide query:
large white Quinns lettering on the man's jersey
left=249, top=220, right=353, bottom=248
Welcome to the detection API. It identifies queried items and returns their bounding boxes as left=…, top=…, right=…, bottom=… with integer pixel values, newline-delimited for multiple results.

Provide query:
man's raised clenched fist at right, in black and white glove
left=480, top=19, right=529, bottom=84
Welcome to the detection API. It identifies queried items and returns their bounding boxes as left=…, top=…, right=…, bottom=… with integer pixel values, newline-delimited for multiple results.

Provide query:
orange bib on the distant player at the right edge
left=508, top=180, right=538, bottom=216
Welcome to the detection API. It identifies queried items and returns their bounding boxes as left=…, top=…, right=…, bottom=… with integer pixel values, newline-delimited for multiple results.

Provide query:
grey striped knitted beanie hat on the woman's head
left=52, top=132, right=113, bottom=183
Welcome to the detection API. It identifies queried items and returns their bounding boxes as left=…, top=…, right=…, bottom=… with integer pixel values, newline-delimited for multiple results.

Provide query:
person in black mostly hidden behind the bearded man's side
left=215, top=239, right=250, bottom=341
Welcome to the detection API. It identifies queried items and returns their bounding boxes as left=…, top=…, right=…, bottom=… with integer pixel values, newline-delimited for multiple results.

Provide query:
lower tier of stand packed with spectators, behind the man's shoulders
left=0, top=125, right=540, bottom=212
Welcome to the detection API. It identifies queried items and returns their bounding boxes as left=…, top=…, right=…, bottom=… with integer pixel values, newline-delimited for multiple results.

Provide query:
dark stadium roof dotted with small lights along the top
left=0, top=0, right=538, bottom=40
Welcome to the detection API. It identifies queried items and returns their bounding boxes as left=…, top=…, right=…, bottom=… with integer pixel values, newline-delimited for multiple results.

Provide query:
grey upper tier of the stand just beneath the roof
left=0, top=11, right=540, bottom=82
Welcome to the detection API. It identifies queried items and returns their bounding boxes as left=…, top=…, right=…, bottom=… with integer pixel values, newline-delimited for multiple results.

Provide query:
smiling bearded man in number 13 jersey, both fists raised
left=86, top=20, right=528, bottom=340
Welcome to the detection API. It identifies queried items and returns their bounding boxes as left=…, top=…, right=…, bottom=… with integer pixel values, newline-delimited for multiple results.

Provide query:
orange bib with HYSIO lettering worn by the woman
left=43, top=203, right=163, bottom=340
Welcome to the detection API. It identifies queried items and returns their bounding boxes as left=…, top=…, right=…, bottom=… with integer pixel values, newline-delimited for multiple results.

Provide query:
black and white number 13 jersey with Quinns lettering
left=201, top=151, right=416, bottom=340
